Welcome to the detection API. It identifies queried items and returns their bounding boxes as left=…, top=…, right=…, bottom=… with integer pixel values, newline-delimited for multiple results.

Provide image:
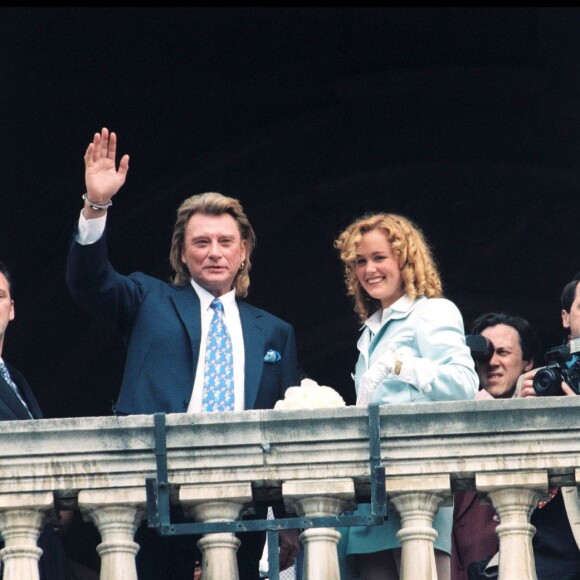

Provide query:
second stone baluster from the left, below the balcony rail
left=78, top=486, right=146, bottom=580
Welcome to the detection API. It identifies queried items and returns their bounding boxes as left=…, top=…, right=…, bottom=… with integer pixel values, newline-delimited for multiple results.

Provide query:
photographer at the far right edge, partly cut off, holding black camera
left=520, top=272, right=580, bottom=580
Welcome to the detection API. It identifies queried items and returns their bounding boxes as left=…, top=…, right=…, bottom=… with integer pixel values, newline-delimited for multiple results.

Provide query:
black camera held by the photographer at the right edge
left=533, top=338, right=580, bottom=397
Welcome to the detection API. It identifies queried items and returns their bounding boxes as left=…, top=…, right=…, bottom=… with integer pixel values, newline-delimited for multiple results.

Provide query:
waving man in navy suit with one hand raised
left=66, top=128, right=299, bottom=580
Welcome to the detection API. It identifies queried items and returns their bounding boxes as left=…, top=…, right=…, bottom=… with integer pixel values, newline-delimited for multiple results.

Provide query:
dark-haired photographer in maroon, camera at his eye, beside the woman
left=451, top=312, right=541, bottom=580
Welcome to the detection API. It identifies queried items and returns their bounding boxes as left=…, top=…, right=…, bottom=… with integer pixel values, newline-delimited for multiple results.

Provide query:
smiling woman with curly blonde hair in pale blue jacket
left=335, top=213, right=478, bottom=580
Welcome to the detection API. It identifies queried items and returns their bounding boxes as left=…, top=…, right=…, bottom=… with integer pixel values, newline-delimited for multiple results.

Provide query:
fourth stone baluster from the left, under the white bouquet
left=282, top=479, right=355, bottom=580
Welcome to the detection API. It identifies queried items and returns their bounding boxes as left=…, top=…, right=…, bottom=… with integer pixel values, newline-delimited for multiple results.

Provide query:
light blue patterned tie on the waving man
left=203, top=298, right=234, bottom=413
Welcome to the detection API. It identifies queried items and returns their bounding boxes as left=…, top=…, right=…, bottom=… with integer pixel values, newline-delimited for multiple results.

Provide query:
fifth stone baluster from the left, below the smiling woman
left=386, top=474, right=451, bottom=580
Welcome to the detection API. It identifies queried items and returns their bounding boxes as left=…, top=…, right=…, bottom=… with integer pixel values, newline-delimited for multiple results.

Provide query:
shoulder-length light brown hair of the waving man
left=169, top=192, right=256, bottom=297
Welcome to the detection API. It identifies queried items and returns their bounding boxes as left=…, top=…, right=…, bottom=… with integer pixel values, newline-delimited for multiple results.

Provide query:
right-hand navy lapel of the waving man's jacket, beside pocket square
left=238, top=300, right=265, bottom=409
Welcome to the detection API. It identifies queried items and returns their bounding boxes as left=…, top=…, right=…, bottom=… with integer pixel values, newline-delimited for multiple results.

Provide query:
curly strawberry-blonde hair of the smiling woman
left=334, top=213, right=443, bottom=322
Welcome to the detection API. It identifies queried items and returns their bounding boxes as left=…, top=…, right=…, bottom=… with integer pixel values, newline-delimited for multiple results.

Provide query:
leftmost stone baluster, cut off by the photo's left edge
left=0, top=492, right=54, bottom=580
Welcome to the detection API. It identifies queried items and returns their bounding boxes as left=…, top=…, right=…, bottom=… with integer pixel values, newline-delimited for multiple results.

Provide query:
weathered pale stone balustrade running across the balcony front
left=0, top=397, right=580, bottom=580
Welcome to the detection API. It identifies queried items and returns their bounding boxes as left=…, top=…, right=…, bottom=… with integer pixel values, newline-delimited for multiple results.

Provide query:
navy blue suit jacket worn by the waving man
left=66, top=228, right=299, bottom=414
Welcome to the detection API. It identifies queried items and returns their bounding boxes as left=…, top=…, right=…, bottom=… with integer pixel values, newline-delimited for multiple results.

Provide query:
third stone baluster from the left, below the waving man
left=179, top=483, right=252, bottom=580
